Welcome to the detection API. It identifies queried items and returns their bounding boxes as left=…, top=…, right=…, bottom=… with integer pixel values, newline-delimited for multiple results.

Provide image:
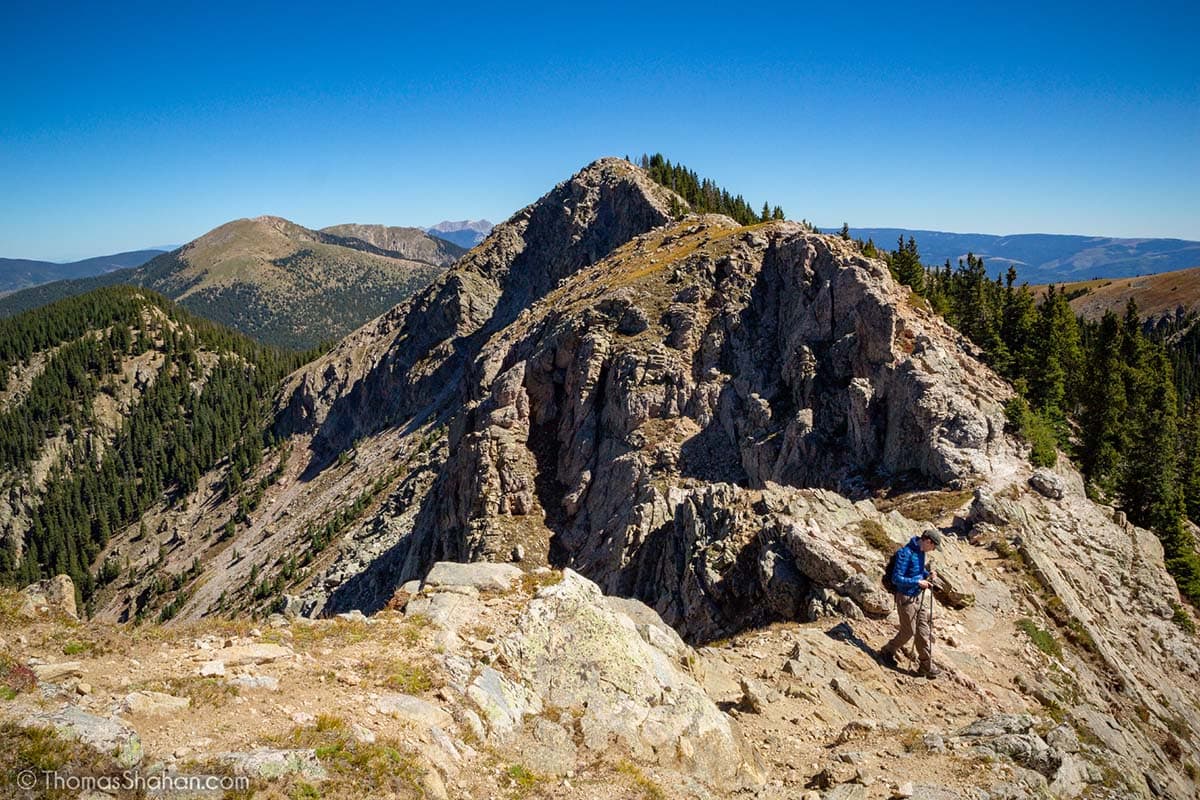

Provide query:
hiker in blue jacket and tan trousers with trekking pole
left=880, top=528, right=942, bottom=678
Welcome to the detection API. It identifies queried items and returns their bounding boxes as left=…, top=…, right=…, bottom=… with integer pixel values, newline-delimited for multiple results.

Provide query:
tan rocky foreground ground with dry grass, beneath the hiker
left=0, top=520, right=1186, bottom=800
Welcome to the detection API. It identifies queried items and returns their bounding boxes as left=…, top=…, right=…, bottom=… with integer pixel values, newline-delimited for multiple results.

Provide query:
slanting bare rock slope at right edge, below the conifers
left=968, top=462, right=1200, bottom=798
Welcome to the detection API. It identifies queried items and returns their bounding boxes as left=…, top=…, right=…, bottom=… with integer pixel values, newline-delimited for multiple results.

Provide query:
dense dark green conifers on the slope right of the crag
left=878, top=237, right=1200, bottom=604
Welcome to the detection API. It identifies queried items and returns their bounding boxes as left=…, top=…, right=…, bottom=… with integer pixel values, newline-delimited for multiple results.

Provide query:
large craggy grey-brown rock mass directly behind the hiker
left=381, top=217, right=1012, bottom=638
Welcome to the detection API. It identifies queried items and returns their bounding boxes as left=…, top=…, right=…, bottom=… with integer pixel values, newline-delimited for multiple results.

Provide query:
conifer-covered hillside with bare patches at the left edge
left=0, top=287, right=314, bottom=600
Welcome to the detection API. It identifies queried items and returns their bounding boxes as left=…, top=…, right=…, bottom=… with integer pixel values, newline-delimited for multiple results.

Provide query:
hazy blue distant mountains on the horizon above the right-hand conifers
left=826, top=228, right=1200, bottom=283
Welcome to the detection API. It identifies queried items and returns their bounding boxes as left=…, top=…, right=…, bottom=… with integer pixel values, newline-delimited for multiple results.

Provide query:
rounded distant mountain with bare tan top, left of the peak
left=0, top=217, right=466, bottom=349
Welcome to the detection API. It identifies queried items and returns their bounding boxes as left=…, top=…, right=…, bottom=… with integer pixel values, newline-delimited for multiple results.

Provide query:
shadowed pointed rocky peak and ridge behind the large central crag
left=276, top=158, right=670, bottom=453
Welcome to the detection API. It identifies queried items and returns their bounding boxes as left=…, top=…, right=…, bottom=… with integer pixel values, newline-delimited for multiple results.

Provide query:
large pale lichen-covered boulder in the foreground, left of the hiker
left=406, top=564, right=763, bottom=790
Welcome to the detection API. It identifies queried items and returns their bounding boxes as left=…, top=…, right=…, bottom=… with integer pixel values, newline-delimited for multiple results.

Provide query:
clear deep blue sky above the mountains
left=0, top=0, right=1200, bottom=259
